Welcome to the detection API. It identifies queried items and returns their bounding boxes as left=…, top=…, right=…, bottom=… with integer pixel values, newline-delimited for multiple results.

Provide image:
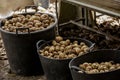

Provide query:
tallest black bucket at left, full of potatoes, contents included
left=0, top=6, right=57, bottom=75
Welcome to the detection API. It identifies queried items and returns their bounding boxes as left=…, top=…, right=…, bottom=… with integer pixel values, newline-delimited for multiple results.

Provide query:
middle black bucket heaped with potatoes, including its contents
left=37, top=36, right=93, bottom=80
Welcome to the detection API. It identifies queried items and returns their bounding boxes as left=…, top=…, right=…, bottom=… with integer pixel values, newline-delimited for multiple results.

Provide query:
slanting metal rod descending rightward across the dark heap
left=70, top=20, right=120, bottom=41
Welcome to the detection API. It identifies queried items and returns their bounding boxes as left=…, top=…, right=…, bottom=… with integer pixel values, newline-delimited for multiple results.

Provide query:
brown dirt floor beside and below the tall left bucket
left=0, top=37, right=46, bottom=80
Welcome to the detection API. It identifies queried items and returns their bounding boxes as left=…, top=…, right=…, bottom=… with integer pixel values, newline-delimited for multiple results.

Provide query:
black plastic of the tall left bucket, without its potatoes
left=0, top=13, right=57, bottom=76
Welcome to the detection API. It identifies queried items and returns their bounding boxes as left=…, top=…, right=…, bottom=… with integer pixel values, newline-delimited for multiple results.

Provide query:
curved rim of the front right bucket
left=69, top=49, right=120, bottom=75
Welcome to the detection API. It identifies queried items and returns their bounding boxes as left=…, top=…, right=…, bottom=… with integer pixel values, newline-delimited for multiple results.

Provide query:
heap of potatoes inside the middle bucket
left=39, top=36, right=89, bottom=59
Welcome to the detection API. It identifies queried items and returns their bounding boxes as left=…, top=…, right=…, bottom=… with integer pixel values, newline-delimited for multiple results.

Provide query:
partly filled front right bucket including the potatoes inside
left=69, top=49, right=120, bottom=80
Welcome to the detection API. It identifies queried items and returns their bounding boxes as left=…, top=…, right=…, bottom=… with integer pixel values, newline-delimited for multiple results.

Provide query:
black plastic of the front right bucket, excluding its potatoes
left=69, top=50, right=120, bottom=80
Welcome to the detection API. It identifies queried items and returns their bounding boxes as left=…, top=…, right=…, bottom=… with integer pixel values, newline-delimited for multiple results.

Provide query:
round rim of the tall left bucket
left=0, top=12, right=58, bottom=35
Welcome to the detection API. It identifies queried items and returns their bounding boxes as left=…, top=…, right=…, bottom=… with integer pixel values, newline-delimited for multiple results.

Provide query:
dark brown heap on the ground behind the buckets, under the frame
left=60, top=23, right=120, bottom=49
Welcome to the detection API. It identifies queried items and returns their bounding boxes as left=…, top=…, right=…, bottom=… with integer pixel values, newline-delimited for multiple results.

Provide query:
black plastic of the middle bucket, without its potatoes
left=37, top=38, right=93, bottom=80
